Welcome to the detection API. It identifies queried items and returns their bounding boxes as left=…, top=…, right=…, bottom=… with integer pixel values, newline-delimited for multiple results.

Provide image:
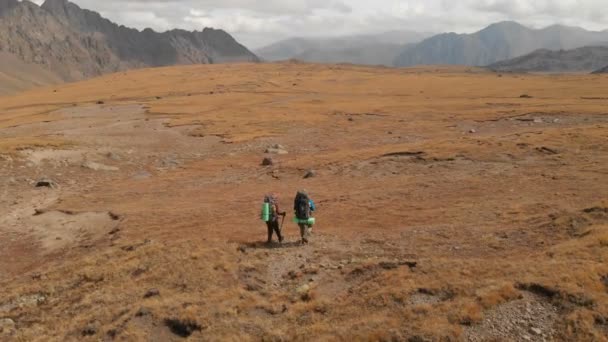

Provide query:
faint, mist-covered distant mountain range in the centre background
left=255, top=31, right=432, bottom=66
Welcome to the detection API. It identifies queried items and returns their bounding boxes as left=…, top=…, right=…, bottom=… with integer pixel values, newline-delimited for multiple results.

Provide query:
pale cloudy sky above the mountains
left=35, top=0, right=608, bottom=48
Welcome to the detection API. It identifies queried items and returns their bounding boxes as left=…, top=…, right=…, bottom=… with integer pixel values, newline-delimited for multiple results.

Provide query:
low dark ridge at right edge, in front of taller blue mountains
left=488, top=46, right=608, bottom=72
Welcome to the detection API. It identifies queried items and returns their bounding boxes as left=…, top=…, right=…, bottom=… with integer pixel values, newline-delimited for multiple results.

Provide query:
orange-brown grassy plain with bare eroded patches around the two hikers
left=0, top=64, right=608, bottom=341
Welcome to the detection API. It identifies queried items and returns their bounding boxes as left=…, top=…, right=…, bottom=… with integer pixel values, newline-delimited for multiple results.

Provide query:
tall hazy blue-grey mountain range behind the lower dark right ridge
left=394, top=22, right=608, bottom=66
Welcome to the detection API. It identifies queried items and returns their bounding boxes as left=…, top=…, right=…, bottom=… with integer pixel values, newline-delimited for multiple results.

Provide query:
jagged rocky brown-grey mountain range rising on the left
left=0, top=0, right=258, bottom=85
